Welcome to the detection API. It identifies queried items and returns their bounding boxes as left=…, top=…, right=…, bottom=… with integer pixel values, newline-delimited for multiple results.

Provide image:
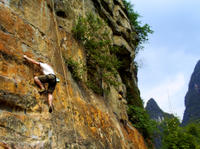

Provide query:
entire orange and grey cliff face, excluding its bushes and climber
left=0, top=0, right=146, bottom=149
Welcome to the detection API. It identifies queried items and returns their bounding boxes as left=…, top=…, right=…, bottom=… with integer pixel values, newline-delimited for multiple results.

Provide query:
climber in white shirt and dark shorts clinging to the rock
left=23, top=55, right=57, bottom=113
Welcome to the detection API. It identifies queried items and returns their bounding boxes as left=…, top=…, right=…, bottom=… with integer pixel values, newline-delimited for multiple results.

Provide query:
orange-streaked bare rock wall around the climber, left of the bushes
left=0, top=0, right=146, bottom=149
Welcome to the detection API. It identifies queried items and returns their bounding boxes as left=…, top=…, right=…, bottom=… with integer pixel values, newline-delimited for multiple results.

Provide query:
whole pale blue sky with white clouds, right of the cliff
left=129, top=0, right=200, bottom=120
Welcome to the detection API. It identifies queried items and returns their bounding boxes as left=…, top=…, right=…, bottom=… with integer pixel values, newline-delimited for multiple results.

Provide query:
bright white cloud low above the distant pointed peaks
left=142, top=73, right=186, bottom=117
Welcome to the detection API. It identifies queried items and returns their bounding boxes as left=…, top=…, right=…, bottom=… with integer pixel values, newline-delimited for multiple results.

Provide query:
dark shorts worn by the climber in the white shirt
left=38, top=74, right=56, bottom=94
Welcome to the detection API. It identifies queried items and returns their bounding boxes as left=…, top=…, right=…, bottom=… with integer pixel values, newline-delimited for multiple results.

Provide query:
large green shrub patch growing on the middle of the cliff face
left=73, top=14, right=121, bottom=94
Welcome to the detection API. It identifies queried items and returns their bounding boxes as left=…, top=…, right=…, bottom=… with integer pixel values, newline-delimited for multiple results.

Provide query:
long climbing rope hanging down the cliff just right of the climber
left=51, top=0, right=79, bottom=149
